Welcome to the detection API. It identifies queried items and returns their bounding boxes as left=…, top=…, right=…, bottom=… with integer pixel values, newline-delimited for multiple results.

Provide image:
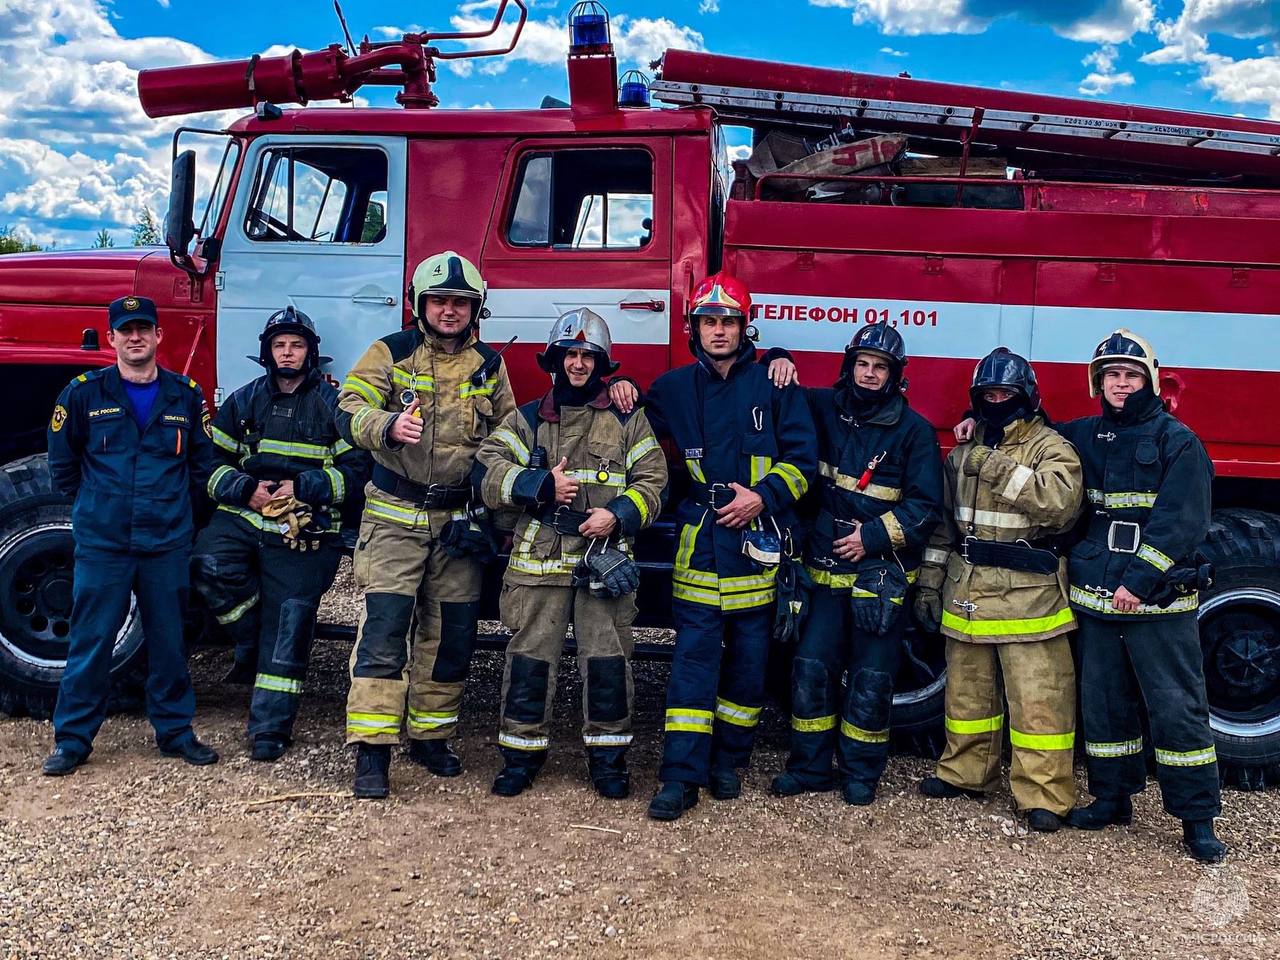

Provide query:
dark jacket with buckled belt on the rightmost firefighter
left=1057, top=387, right=1213, bottom=620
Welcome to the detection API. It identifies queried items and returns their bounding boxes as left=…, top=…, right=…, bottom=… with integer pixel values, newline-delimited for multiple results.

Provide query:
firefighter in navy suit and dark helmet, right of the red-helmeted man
left=771, top=324, right=942, bottom=805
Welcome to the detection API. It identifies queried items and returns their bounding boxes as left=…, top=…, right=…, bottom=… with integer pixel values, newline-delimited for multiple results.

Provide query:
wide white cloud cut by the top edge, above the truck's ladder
left=809, top=0, right=1156, bottom=44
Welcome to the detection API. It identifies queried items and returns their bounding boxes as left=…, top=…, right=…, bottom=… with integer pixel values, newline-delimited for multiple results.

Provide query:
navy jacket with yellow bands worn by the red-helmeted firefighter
left=645, top=351, right=817, bottom=613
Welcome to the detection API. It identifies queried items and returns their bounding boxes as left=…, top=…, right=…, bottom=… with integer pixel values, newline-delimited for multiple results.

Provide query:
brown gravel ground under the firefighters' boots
left=0, top=560, right=1280, bottom=960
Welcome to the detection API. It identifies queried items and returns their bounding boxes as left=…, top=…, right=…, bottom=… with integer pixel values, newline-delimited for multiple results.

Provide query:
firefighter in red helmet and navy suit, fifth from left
left=646, top=273, right=817, bottom=820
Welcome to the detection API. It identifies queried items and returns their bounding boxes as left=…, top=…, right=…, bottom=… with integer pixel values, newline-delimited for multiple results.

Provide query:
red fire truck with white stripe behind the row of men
left=0, top=0, right=1280, bottom=787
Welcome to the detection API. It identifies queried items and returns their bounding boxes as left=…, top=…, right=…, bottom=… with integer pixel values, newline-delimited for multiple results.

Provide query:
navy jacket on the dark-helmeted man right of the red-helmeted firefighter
left=805, top=388, right=942, bottom=590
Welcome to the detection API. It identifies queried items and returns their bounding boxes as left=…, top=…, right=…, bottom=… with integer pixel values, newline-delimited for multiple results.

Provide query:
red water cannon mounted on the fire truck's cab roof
left=138, top=0, right=524, bottom=118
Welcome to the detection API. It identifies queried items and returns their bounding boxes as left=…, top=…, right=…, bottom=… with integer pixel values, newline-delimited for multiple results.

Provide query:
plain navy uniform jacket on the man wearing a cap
left=49, top=366, right=214, bottom=553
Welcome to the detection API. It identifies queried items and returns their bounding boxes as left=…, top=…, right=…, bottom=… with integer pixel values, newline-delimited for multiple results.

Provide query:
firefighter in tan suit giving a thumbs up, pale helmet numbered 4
left=338, top=251, right=516, bottom=799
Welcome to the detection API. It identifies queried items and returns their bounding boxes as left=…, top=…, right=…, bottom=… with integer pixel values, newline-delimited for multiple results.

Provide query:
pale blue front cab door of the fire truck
left=218, top=137, right=406, bottom=392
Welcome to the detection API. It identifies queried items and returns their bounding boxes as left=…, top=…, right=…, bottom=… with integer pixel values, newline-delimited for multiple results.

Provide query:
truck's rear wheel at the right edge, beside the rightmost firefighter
left=1199, top=509, right=1280, bottom=790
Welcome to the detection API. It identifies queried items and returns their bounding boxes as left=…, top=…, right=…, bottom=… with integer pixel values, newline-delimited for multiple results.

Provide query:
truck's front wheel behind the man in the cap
left=0, top=453, right=143, bottom=719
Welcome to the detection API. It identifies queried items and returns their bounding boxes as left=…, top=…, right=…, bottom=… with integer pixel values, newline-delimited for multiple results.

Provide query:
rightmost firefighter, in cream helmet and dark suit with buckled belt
left=1062, top=329, right=1226, bottom=863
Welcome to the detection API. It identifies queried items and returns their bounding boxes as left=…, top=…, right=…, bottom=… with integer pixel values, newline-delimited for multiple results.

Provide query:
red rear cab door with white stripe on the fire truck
left=483, top=137, right=672, bottom=397
